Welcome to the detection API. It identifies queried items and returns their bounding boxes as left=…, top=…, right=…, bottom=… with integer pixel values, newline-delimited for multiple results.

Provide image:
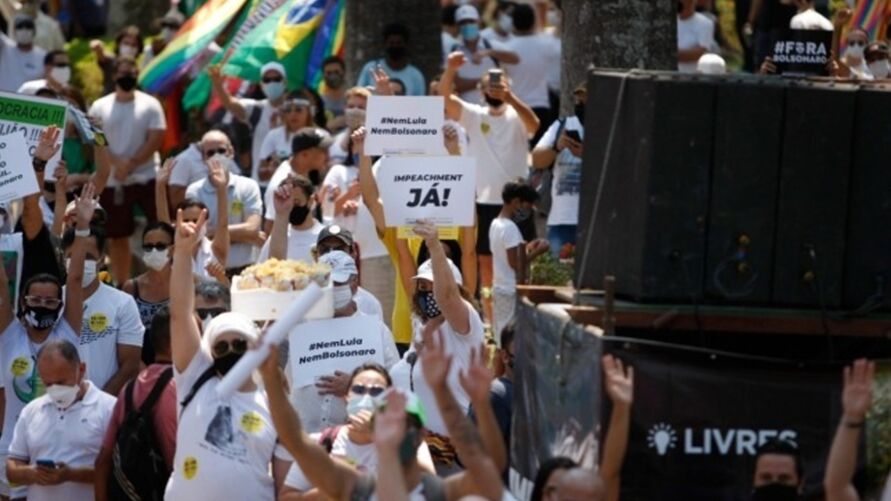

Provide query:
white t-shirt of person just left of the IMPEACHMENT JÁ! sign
left=322, top=164, right=389, bottom=260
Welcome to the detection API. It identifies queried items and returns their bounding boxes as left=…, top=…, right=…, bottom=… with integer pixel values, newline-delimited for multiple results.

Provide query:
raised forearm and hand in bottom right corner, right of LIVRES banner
left=823, top=358, right=876, bottom=501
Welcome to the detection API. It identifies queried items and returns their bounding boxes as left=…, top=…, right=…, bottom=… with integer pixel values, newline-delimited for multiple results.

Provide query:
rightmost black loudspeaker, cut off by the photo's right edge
left=843, top=85, right=891, bottom=310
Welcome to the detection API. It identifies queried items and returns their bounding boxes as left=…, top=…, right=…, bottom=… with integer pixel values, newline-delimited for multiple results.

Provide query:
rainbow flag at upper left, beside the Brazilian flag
left=139, top=0, right=247, bottom=95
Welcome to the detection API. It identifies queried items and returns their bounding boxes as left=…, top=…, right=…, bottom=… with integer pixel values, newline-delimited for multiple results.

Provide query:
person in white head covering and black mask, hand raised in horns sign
left=165, top=206, right=289, bottom=501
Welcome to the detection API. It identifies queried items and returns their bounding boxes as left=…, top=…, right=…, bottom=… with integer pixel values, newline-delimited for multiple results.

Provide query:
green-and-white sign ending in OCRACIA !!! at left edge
left=0, top=92, right=68, bottom=180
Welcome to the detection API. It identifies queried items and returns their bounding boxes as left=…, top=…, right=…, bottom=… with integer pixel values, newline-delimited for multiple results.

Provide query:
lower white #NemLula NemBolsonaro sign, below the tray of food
left=288, top=315, right=384, bottom=388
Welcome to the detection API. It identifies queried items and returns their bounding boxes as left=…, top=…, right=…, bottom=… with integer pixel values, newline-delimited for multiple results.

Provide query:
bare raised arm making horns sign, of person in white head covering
left=170, top=210, right=207, bottom=372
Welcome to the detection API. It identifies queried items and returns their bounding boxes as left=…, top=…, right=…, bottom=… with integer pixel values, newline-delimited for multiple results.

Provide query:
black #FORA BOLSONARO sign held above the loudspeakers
left=771, top=30, right=832, bottom=76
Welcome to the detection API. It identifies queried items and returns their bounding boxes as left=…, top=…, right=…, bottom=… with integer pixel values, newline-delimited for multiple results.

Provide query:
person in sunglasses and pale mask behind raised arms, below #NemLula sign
left=279, top=363, right=436, bottom=501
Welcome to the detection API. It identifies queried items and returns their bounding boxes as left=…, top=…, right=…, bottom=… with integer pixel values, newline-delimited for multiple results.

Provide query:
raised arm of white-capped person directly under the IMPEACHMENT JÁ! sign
left=414, top=222, right=470, bottom=334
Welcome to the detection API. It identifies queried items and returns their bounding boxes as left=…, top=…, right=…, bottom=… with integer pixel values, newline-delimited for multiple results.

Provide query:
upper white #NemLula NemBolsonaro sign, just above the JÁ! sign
left=365, top=96, right=445, bottom=156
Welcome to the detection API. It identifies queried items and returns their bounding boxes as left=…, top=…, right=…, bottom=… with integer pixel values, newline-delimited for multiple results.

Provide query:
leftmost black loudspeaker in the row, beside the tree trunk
left=576, top=71, right=715, bottom=301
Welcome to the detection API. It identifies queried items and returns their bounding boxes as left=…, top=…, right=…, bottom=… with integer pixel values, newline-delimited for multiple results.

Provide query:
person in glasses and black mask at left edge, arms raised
left=0, top=186, right=94, bottom=499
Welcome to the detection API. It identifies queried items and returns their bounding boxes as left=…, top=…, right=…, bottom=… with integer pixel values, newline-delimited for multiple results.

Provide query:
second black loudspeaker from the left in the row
left=705, top=77, right=785, bottom=304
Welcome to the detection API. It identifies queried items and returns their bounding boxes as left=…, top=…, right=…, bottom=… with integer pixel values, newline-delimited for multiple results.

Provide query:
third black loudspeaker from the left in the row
left=772, top=83, right=857, bottom=308
